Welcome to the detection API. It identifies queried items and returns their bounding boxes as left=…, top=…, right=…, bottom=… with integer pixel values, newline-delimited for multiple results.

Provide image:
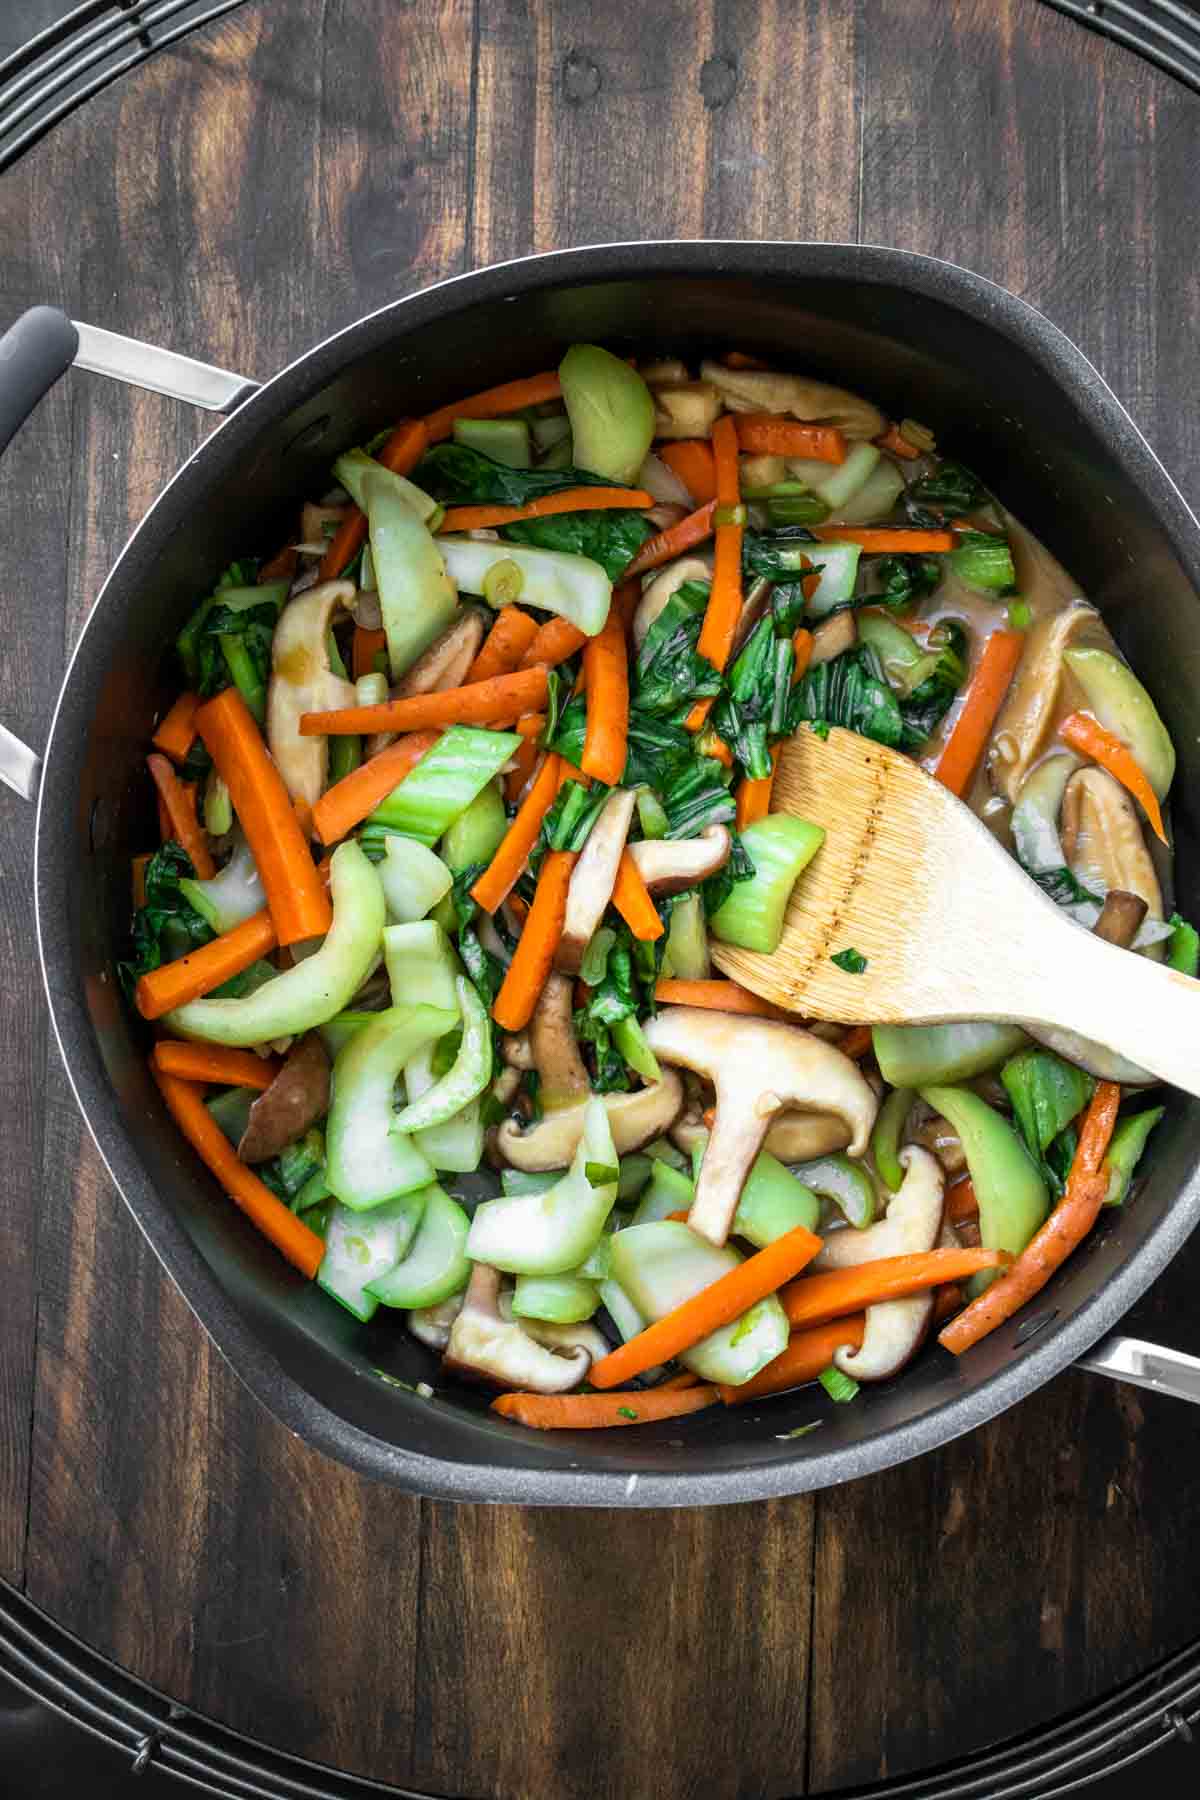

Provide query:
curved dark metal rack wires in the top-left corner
left=0, top=0, right=253, bottom=173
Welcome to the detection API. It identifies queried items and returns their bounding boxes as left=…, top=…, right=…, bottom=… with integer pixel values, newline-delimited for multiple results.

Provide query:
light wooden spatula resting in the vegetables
left=712, top=729, right=1200, bottom=1094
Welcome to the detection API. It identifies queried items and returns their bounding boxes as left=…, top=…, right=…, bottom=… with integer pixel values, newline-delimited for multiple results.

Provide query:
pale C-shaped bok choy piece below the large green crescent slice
left=326, top=1006, right=455, bottom=1209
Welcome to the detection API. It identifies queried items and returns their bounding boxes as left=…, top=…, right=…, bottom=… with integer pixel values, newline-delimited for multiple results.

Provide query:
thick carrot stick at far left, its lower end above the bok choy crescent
left=196, top=688, right=333, bottom=943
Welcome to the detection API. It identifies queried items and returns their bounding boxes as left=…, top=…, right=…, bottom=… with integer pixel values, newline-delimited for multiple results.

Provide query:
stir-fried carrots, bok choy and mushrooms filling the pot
left=122, top=344, right=1200, bottom=1427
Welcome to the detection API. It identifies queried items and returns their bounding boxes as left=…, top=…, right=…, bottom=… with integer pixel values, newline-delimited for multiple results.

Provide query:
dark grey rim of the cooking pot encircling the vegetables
left=34, top=238, right=1200, bottom=1507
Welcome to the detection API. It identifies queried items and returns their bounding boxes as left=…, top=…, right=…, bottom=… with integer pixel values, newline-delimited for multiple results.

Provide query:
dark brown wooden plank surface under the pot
left=0, top=0, right=1200, bottom=1800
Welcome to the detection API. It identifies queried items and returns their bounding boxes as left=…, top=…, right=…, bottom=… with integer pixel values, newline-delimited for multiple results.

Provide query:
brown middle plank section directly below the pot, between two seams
left=410, top=1499, right=811, bottom=1800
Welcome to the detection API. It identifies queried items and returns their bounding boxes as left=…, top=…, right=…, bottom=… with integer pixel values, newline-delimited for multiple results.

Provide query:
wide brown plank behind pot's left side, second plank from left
left=25, top=0, right=473, bottom=1780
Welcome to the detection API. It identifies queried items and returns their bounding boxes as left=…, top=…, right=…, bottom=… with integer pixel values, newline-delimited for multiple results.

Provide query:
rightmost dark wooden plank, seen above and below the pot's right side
left=810, top=0, right=1200, bottom=1793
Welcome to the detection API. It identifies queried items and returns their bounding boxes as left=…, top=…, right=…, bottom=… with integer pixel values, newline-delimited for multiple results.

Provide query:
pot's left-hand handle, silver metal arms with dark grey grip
left=0, top=306, right=259, bottom=799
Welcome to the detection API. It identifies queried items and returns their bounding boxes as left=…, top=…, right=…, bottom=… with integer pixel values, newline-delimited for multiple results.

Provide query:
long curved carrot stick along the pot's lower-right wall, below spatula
left=937, top=1082, right=1121, bottom=1355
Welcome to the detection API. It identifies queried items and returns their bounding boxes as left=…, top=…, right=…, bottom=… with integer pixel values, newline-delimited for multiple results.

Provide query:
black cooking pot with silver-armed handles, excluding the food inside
left=0, top=243, right=1200, bottom=1507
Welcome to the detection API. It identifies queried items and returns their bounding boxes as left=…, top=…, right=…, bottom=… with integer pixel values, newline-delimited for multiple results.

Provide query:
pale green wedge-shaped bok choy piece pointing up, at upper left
left=362, top=468, right=459, bottom=680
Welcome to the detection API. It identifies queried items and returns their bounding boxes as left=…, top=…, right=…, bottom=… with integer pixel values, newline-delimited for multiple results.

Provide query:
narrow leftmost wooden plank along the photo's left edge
left=0, top=144, right=72, bottom=1584
